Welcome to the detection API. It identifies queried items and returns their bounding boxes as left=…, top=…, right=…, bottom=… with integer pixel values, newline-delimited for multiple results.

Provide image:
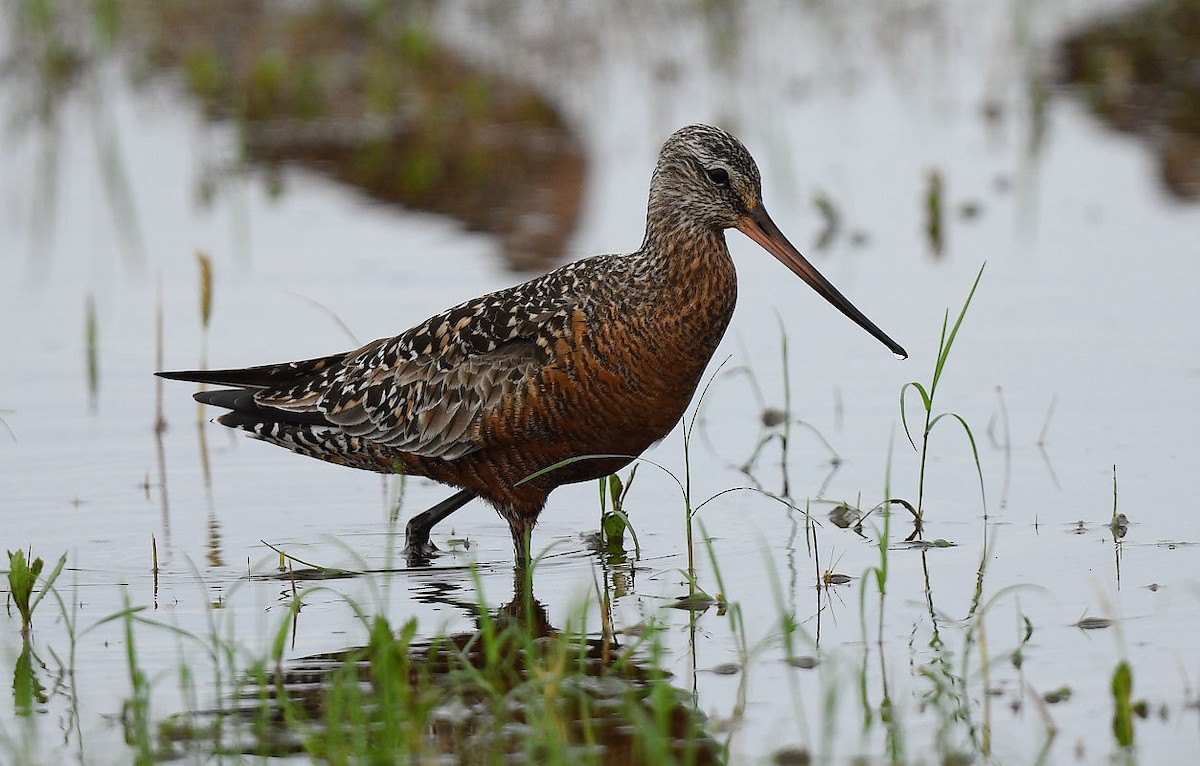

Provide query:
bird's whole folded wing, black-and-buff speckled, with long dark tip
left=184, top=256, right=628, bottom=460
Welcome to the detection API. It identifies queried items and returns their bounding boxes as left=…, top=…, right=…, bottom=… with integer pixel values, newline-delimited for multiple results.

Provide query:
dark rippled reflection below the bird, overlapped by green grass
left=196, top=573, right=722, bottom=765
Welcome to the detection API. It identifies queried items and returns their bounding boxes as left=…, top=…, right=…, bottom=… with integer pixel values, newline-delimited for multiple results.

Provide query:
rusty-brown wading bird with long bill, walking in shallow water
left=158, top=125, right=906, bottom=563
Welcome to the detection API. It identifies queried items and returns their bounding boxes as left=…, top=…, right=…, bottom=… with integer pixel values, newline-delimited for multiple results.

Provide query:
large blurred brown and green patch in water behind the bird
left=138, top=0, right=584, bottom=269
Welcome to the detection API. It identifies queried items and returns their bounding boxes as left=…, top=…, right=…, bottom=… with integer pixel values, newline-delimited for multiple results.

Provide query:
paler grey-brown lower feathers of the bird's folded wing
left=256, top=337, right=548, bottom=460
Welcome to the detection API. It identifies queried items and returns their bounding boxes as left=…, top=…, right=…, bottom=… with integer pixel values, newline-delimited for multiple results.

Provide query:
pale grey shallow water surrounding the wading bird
left=0, top=2, right=1200, bottom=764
